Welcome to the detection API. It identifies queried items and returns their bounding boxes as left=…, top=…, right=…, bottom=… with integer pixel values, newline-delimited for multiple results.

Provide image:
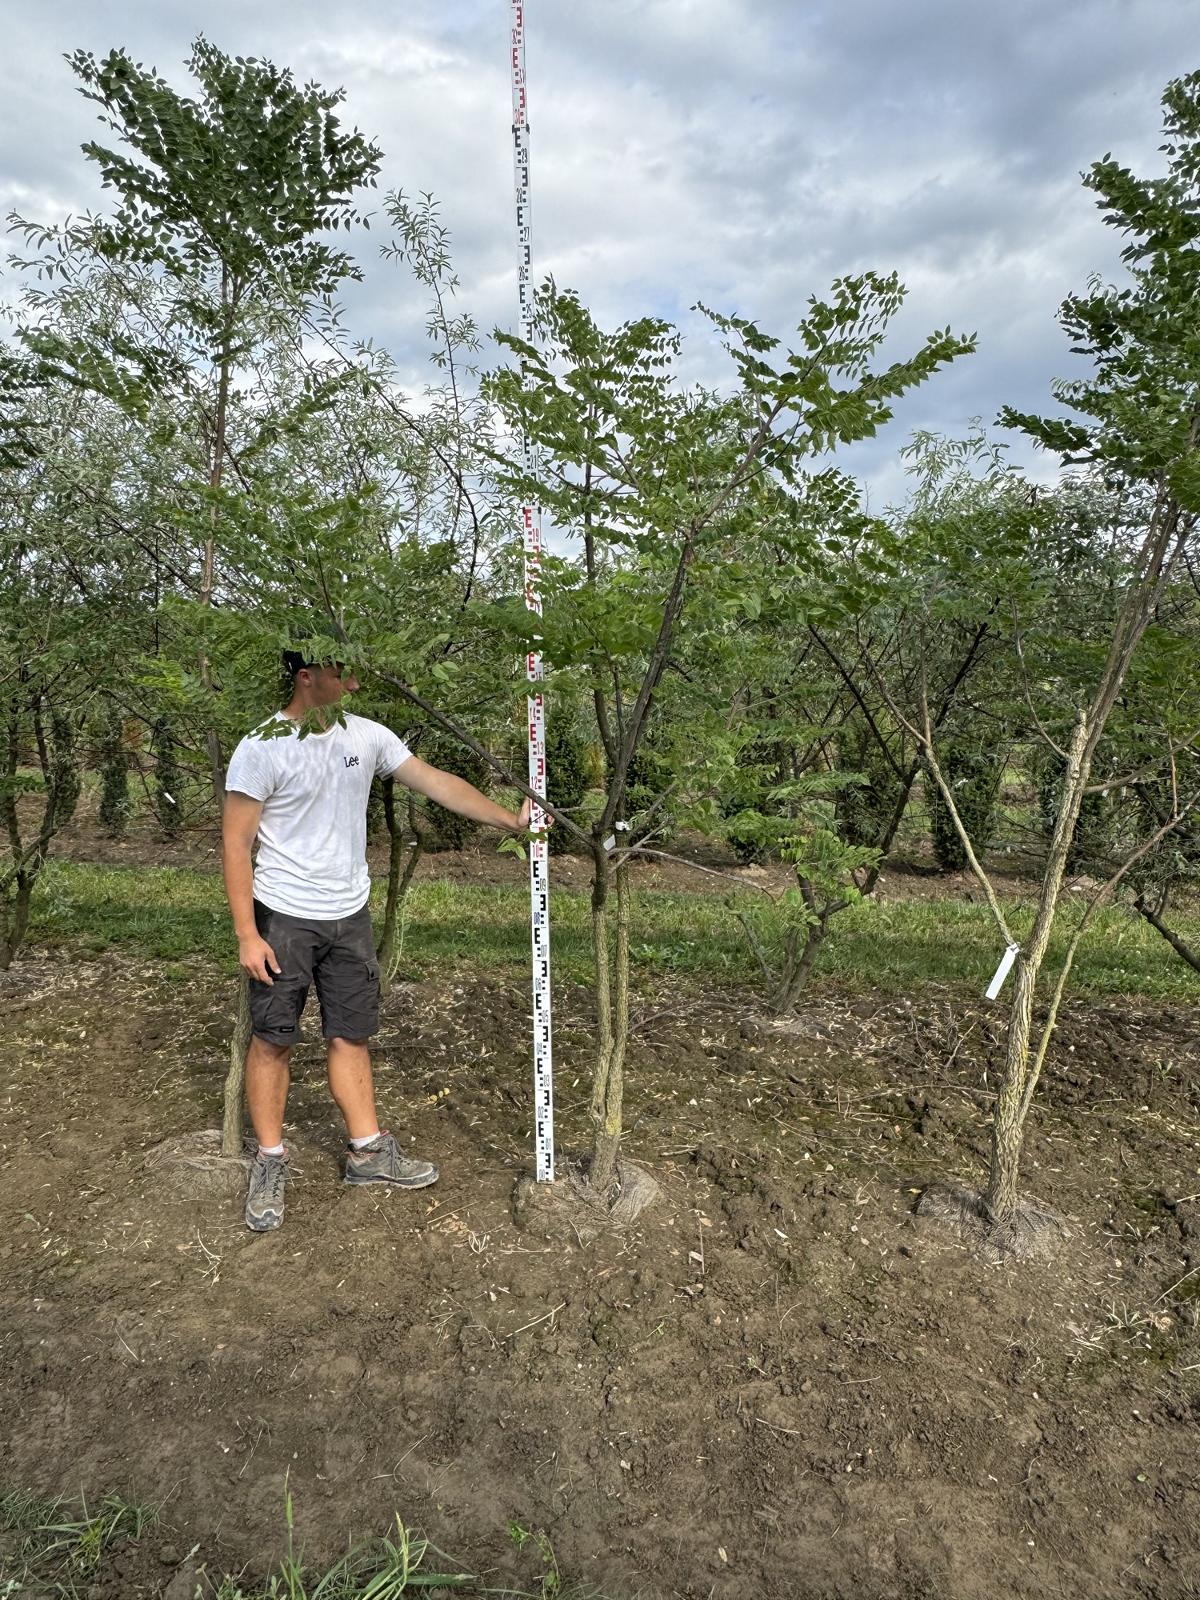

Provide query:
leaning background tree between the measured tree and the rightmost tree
left=710, top=438, right=1027, bottom=1011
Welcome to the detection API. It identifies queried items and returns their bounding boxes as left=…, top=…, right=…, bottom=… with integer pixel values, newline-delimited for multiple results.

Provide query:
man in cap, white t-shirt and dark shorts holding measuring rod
left=222, top=651, right=530, bottom=1232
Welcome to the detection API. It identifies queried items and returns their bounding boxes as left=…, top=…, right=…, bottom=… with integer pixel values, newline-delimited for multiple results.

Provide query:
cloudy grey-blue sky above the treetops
left=0, top=0, right=1200, bottom=506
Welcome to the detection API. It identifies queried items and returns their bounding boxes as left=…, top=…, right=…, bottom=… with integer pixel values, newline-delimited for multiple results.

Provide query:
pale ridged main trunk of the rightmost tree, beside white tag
left=984, top=712, right=1091, bottom=1227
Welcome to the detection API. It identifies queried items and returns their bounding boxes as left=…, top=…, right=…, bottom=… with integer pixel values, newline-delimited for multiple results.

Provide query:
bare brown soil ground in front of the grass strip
left=0, top=921, right=1200, bottom=1600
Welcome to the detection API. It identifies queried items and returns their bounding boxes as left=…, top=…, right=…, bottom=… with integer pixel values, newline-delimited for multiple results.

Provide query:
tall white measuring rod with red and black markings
left=509, top=0, right=554, bottom=1184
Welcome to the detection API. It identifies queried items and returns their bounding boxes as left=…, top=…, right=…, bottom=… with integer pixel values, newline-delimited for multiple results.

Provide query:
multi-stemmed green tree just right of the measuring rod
left=488, top=274, right=971, bottom=1197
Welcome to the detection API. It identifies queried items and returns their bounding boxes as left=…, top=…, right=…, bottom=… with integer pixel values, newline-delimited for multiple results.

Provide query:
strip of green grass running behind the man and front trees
left=30, top=861, right=1200, bottom=1002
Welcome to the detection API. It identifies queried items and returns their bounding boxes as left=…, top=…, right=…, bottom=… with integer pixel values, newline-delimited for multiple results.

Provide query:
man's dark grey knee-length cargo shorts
left=250, top=901, right=379, bottom=1045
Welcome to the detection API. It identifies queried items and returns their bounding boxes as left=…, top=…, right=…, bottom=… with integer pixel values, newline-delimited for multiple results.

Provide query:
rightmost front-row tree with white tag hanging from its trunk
left=889, top=74, right=1200, bottom=1248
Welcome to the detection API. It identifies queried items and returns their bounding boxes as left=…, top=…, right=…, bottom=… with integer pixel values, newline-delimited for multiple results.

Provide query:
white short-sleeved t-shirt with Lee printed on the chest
left=226, top=714, right=413, bottom=922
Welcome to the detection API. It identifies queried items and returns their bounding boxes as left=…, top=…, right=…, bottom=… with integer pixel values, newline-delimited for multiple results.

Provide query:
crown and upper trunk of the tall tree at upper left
left=13, top=38, right=379, bottom=808
